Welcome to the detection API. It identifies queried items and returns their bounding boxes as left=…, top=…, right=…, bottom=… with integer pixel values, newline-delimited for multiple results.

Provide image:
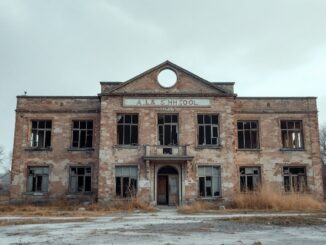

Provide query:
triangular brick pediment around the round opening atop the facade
left=103, top=61, right=233, bottom=96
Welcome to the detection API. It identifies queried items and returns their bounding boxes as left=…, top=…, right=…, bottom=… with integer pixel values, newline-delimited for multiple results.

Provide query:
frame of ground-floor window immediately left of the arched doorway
left=114, top=165, right=139, bottom=199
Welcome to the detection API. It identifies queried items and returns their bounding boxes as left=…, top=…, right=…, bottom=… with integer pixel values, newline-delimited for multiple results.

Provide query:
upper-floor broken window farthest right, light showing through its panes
left=281, top=120, right=303, bottom=149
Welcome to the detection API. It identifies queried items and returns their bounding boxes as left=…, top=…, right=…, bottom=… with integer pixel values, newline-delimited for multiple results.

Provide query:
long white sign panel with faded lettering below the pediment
left=123, top=98, right=211, bottom=107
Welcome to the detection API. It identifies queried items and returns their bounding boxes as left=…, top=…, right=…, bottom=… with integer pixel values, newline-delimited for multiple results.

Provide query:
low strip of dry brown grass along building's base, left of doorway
left=0, top=197, right=157, bottom=217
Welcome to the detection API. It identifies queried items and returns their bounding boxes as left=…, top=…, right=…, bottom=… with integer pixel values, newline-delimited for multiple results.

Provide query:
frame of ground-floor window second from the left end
left=68, top=165, right=93, bottom=194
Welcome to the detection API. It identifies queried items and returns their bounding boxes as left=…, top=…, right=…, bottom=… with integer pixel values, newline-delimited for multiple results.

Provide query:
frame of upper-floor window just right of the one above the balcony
left=195, top=113, right=221, bottom=148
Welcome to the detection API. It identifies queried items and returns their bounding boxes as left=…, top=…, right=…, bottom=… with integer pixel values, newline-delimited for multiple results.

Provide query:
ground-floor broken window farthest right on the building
left=283, top=167, right=307, bottom=192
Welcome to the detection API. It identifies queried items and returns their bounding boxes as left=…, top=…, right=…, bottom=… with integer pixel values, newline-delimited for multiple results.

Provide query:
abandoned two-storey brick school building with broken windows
left=10, top=61, right=323, bottom=205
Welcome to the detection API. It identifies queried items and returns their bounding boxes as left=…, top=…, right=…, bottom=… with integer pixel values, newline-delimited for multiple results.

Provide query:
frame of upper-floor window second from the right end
left=236, top=119, right=260, bottom=150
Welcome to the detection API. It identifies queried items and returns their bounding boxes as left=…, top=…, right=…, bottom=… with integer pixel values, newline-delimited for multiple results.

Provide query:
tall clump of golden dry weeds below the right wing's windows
left=229, top=186, right=326, bottom=211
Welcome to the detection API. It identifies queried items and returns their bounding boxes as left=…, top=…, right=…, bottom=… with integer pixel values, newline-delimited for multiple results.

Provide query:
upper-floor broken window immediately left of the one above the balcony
left=117, top=114, right=138, bottom=145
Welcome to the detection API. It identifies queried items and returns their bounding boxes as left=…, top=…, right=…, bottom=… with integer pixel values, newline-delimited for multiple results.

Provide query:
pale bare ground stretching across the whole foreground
left=0, top=209, right=326, bottom=244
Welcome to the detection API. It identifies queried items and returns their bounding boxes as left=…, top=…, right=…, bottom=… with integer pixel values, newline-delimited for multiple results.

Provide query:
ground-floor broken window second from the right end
left=240, top=167, right=260, bottom=192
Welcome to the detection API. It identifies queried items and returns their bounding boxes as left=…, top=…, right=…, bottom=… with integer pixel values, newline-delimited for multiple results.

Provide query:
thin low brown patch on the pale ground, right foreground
left=223, top=215, right=326, bottom=226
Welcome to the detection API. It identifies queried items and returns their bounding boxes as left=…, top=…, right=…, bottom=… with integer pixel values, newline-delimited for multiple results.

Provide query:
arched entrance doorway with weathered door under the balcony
left=157, top=166, right=179, bottom=206
